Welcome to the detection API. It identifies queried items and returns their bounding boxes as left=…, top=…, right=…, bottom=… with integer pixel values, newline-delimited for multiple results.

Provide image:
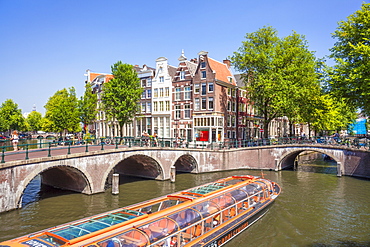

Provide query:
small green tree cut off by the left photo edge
left=0, top=99, right=25, bottom=131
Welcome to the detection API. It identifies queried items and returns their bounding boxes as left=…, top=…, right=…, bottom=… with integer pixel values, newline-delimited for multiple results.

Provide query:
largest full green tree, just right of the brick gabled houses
left=231, top=27, right=320, bottom=138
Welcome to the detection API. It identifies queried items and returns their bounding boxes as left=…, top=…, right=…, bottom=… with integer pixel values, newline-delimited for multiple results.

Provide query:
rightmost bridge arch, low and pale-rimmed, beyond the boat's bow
left=276, top=148, right=340, bottom=170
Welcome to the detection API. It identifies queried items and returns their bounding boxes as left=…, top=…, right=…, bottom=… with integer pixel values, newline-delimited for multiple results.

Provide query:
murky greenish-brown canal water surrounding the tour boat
left=0, top=158, right=370, bottom=247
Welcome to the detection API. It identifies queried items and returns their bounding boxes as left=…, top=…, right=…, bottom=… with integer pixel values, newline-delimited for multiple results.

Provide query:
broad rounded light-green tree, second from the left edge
left=43, top=87, right=81, bottom=134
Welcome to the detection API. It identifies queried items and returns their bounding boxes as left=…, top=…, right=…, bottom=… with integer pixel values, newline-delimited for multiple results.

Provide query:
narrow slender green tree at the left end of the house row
left=78, top=82, right=98, bottom=133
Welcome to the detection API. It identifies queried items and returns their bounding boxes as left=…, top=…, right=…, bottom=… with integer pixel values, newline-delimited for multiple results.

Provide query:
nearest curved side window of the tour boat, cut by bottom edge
left=98, top=229, right=148, bottom=247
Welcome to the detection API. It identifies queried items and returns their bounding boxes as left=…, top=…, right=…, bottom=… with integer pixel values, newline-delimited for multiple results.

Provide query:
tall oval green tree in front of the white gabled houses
left=102, top=61, right=143, bottom=136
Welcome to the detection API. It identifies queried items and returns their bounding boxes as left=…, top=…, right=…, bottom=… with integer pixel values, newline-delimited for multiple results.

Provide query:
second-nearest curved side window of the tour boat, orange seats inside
left=137, top=218, right=178, bottom=242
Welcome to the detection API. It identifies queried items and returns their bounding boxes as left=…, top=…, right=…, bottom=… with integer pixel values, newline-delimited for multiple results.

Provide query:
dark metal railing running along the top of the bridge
left=0, top=136, right=370, bottom=163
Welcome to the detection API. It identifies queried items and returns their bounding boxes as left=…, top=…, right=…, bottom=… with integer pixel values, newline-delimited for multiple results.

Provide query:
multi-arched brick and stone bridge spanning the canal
left=0, top=144, right=370, bottom=212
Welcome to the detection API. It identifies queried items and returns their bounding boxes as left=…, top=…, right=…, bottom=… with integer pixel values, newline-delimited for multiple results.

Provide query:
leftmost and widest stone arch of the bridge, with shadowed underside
left=16, top=165, right=92, bottom=208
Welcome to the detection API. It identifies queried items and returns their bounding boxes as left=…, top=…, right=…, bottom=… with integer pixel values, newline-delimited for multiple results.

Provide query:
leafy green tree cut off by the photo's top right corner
left=330, top=3, right=370, bottom=115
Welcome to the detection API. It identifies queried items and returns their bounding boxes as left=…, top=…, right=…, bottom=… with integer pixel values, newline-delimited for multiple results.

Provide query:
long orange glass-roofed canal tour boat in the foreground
left=0, top=175, right=281, bottom=247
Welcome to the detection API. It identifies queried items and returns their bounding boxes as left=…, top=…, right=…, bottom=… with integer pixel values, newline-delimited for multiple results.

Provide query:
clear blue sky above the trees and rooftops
left=0, top=0, right=369, bottom=113
